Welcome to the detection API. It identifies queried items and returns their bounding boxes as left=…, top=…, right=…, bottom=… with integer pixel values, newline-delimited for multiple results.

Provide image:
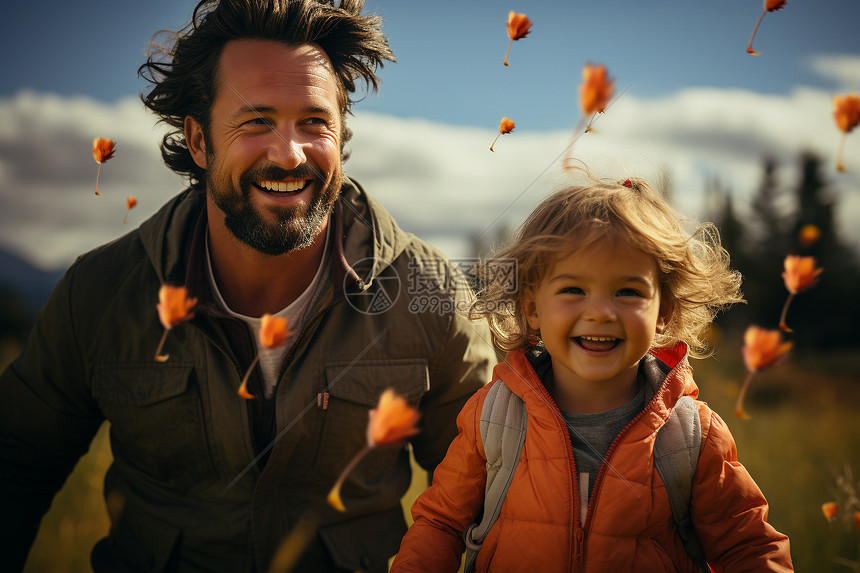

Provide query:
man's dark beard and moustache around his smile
left=206, top=158, right=343, bottom=255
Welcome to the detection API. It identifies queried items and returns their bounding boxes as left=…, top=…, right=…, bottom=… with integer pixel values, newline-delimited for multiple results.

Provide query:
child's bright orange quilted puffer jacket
left=391, top=344, right=793, bottom=573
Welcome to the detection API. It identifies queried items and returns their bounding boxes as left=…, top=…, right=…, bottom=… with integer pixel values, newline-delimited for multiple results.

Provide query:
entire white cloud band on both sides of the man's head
left=0, top=88, right=860, bottom=267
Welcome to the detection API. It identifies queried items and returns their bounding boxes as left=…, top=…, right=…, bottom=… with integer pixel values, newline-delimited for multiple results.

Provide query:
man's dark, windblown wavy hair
left=138, top=0, right=395, bottom=188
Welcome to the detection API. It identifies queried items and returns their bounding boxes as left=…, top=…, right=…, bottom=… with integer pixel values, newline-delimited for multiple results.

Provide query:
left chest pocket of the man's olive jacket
left=93, top=364, right=216, bottom=490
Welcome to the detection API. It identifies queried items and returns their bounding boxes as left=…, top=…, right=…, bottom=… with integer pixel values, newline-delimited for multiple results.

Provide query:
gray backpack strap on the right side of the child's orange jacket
left=654, top=396, right=710, bottom=572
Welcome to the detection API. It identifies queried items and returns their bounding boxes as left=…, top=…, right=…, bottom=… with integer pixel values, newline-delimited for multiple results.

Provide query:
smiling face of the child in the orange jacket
left=525, top=240, right=670, bottom=395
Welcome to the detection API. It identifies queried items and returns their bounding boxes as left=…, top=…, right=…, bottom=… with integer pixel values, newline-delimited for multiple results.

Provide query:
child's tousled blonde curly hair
left=469, top=179, right=744, bottom=357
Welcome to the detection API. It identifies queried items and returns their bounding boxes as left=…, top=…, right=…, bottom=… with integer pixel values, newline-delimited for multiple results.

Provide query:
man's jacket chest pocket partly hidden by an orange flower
left=315, top=360, right=430, bottom=485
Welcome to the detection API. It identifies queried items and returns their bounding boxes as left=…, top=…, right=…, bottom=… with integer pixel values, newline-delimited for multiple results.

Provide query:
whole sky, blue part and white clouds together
left=0, top=0, right=860, bottom=267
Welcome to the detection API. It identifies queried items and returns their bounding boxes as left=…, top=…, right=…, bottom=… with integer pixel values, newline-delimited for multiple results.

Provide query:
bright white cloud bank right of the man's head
left=347, top=88, right=860, bottom=256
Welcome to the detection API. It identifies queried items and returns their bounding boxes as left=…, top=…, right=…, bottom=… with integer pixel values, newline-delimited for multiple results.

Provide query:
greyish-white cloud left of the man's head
left=0, top=92, right=186, bottom=268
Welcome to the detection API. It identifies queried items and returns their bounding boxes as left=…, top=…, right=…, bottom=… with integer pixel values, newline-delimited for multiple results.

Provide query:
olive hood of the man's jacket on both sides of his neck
left=139, top=178, right=412, bottom=290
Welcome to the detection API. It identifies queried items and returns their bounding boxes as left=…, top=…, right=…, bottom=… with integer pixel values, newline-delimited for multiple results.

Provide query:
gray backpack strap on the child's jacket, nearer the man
left=463, top=380, right=527, bottom=573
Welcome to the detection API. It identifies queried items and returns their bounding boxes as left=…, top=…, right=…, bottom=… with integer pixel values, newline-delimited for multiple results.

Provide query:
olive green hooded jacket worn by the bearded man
left=0, top=180, right=495, bottom=573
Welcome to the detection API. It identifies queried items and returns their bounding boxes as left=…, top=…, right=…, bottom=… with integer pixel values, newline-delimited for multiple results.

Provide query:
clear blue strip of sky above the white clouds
left=6, top=0, right=860, bottom=125
